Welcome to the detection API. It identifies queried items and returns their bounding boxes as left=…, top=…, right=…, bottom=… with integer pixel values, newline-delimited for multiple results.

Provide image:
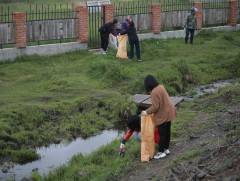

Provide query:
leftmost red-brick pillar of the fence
left=13, top=12, right=27, bottom=48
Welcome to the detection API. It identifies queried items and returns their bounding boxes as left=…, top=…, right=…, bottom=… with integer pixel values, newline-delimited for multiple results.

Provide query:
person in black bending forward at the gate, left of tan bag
left=99, top=19, right=117, bottom=54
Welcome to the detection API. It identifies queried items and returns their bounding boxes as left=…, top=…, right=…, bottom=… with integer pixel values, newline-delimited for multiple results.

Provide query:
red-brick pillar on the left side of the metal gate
left=76, top=5, right=88, bottom=43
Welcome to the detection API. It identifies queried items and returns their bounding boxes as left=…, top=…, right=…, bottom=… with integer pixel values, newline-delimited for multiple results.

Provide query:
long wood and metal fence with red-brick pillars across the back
left=0, top=0, right=240, bottom=59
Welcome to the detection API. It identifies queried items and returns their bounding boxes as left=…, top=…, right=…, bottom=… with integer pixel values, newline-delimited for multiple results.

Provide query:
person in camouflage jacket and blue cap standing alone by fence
left=184, top=7, right=198, bottom=44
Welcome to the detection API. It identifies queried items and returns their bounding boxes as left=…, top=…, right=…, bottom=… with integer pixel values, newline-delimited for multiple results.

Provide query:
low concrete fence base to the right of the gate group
left=138, top=24, right=240, bottom=40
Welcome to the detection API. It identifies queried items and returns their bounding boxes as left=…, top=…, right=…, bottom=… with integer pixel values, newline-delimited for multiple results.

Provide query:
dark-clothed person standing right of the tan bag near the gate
left=120, top=21, right=141, bottom=62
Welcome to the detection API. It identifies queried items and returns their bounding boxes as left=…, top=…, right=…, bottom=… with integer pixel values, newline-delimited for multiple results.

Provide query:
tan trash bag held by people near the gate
left=116, top=35, right=128, bottom=59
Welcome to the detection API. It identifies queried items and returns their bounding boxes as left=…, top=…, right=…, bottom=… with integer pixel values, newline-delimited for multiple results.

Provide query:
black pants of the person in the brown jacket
left=158, top=122, right=171, bottom=152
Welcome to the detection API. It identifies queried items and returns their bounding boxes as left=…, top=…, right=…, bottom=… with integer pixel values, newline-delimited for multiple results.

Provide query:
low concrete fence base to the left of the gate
left=0, top=42, right=88, bottom=62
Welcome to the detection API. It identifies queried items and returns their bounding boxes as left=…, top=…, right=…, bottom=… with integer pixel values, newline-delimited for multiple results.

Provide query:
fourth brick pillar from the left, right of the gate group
left=150, top=4, right=161, bottom=34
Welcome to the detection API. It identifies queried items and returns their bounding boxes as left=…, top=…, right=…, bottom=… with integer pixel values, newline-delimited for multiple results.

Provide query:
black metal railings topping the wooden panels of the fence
left=0, top=0, right=234, bottom=23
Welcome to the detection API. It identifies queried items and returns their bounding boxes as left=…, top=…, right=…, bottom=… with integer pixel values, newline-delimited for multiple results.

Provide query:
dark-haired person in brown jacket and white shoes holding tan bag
left=142, top=75, right=176, bottom=159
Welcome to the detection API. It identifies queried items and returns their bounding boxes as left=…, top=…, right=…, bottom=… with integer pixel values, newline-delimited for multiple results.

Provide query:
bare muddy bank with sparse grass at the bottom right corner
left=117, top=90, right=240, bottom=181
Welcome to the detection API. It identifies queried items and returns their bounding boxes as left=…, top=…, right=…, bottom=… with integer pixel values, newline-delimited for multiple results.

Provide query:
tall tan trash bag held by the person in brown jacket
left=141, top=114, right=155, bottom=162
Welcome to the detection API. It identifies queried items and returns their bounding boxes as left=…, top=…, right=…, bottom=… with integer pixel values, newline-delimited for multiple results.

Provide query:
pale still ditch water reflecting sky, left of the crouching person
left=0, top=130, right=123, bottom=181
